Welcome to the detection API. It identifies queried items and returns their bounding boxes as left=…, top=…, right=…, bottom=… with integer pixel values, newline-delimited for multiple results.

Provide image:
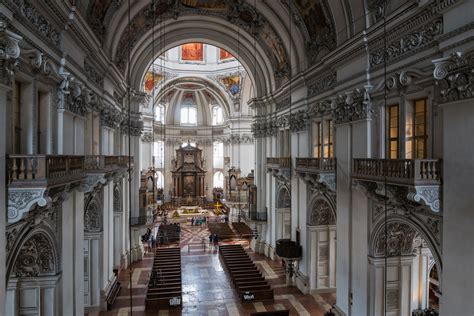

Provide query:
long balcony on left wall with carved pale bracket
left=7, top=155, right=128, bottom=224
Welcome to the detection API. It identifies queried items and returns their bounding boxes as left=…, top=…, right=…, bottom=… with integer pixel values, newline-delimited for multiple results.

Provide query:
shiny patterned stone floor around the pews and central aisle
left=89, top=226, right=335, bottom=316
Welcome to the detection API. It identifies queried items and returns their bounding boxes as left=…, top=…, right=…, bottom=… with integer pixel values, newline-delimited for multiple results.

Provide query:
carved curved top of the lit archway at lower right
left=369, top=214, right=443, bottom=274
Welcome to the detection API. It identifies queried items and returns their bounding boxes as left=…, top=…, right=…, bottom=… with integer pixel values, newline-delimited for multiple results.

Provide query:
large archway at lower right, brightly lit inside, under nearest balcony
left=369, top=215, right=442, bottom=315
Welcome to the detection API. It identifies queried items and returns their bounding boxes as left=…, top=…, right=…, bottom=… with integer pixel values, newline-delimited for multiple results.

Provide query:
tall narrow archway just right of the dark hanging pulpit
left=307, top=194, right=336, bottom=291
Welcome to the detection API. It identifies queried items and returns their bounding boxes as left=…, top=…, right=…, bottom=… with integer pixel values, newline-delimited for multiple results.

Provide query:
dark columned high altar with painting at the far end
left=171, top=144, right=206, bottom=199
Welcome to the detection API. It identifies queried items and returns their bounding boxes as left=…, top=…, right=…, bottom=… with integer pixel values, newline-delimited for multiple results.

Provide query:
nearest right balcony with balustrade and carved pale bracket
left=352, top=158, right=442, bottom=212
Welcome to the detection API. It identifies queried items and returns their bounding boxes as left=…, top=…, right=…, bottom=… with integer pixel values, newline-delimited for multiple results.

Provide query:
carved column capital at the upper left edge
left=0, top=15, right=22, bottom=86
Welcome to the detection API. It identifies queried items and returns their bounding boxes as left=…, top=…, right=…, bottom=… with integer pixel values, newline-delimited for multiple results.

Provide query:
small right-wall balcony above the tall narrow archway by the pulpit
left=295, top=158, right=336, bottom=191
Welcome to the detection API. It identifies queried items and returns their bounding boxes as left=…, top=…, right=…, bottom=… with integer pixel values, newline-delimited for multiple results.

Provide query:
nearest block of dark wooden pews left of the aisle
left=145, top=248, right=182, bottom=310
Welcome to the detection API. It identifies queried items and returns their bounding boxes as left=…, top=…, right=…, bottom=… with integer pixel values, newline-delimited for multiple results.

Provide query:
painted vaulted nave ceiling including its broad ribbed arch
left=79, top=0, right=374, bottom=95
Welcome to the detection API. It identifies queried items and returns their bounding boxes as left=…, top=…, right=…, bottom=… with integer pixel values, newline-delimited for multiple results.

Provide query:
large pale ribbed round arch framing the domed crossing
left=125, top=15, right=278, bottom=96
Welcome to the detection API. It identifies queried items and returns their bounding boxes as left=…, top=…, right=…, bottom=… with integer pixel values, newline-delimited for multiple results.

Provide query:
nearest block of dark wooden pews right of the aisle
left=219, top=245, right=273, bottom=301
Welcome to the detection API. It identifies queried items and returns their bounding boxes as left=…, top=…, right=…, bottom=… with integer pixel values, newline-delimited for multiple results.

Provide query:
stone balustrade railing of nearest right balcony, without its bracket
left=352, top=159, right=441, bottom=184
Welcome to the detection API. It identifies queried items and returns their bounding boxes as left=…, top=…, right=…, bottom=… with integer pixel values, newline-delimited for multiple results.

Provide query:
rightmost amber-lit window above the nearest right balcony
left=405, top=99, right=428, bottom=159
